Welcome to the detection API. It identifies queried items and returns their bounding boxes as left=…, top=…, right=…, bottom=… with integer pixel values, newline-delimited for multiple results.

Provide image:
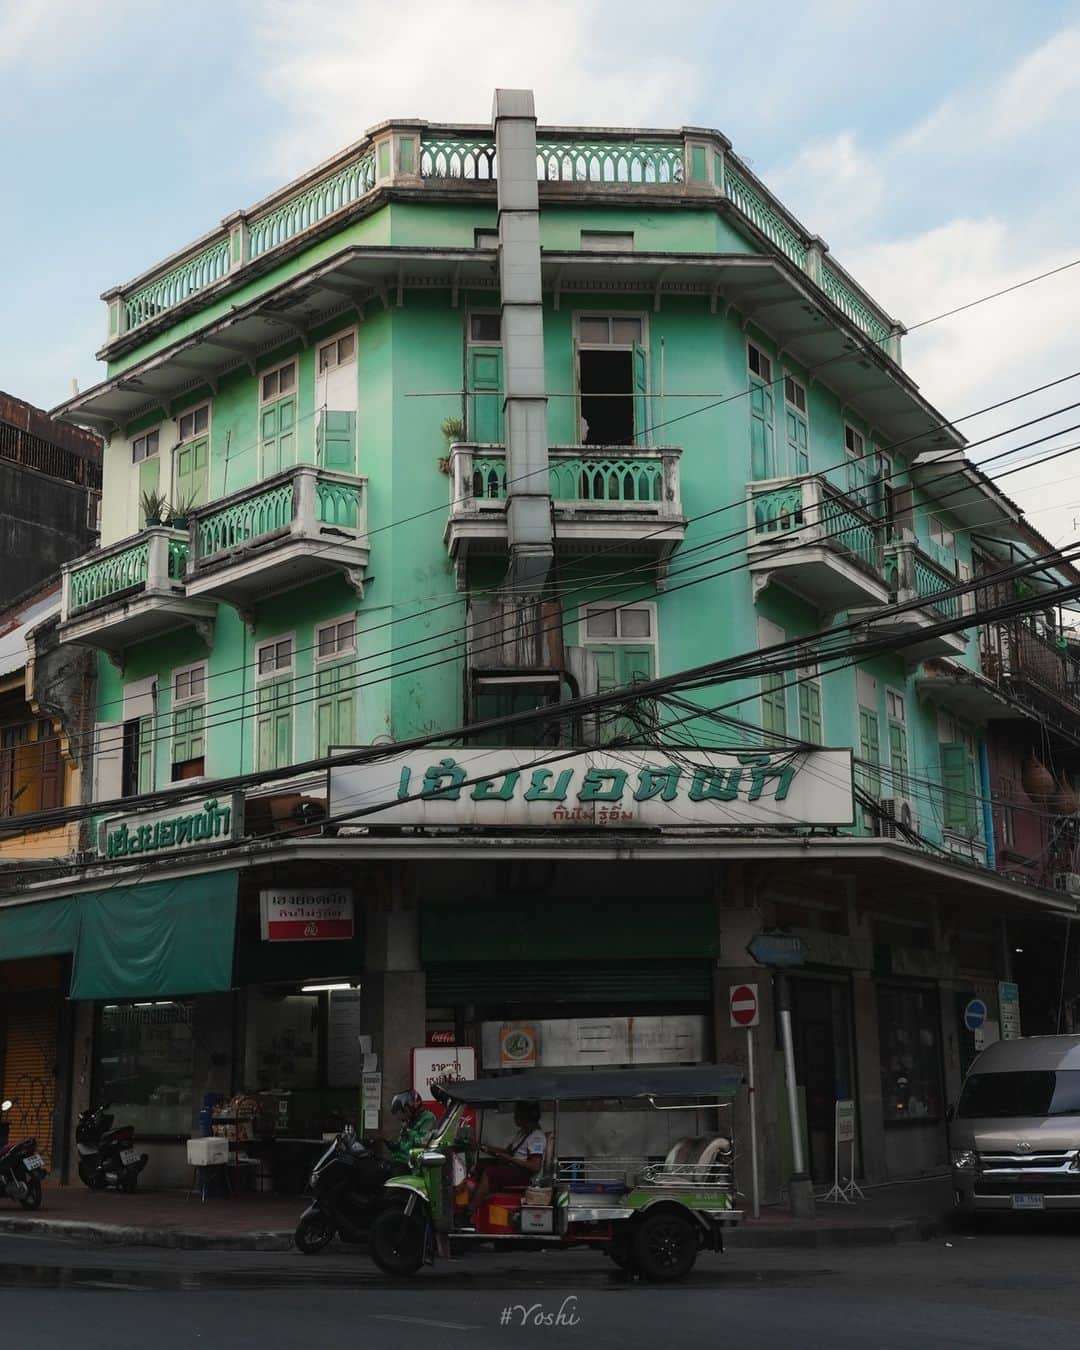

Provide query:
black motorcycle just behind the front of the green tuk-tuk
left=293, top=1125, right=394, bottom=1256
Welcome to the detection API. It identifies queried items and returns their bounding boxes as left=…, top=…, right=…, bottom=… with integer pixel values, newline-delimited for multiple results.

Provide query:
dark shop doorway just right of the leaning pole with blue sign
left=791, top=976, right=855, bottom=1183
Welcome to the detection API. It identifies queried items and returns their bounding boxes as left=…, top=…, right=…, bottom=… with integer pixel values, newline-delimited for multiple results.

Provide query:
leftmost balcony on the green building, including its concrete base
left=58, top=525, right=217, bottom=664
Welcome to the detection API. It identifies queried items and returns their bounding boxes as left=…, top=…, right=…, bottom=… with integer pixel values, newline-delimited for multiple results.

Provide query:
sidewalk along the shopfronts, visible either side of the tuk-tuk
left=0, top=1177, right=952, bottom=1251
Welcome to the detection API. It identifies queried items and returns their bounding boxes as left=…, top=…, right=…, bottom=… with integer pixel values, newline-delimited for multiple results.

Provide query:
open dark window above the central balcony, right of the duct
left=578, top=315, right=649, bottom=446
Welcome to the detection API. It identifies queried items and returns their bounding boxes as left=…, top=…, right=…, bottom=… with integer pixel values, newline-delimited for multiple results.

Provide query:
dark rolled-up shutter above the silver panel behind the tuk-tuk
left=425, top=961, right=713, bottom=1007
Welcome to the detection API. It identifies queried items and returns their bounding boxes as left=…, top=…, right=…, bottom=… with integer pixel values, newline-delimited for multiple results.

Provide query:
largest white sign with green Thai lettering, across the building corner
left=329, top=748, right=853, bottom=829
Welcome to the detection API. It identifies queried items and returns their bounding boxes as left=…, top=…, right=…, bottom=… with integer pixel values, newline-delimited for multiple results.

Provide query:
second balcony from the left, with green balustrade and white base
left=186, top=464, right=369, bottom=621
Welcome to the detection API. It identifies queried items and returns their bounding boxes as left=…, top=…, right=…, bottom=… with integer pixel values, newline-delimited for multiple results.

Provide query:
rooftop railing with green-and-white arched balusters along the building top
left=105, top=122, right=902, bottom=360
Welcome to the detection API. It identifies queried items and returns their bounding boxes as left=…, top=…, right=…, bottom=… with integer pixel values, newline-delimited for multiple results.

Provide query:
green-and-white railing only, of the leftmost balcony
left=61, top=525, right=188, bottom=622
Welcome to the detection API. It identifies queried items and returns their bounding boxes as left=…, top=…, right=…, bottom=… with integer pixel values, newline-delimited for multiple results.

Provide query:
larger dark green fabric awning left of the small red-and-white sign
left=72, top=872, right=238, bottom=999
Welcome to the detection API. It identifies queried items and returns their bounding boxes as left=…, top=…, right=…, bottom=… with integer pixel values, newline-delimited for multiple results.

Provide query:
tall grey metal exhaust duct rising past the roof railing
left=491, top=89, right=554, bottom=599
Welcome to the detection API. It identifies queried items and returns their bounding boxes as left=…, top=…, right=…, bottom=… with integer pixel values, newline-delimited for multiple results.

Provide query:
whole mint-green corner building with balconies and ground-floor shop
left=4, top=90, right=1079, bottom=1195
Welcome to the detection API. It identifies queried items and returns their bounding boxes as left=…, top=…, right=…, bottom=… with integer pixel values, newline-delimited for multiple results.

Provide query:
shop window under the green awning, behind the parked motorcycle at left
left=95, top=1002, right=194, bottom=1137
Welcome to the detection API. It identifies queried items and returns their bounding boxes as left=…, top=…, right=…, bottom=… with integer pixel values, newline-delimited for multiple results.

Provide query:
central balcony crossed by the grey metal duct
left=444, top=444, right=686, bottom=581
